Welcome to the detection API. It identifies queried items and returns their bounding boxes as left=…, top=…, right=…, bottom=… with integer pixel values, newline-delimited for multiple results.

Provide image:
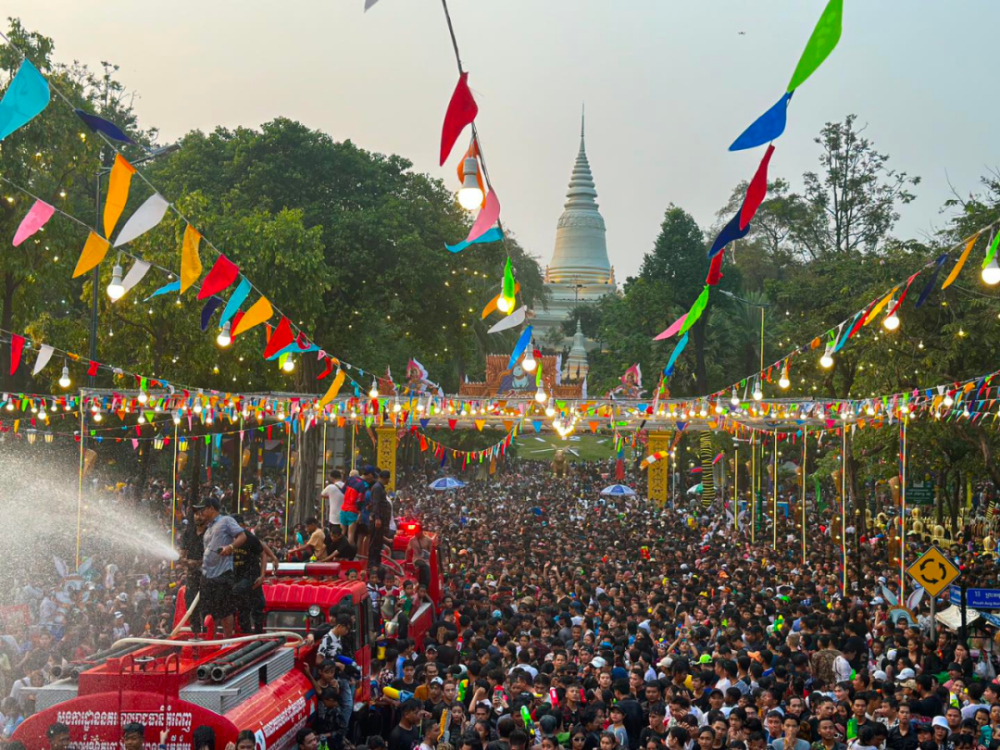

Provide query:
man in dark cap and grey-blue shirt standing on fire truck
left=194, top=497, right=247, bottom=638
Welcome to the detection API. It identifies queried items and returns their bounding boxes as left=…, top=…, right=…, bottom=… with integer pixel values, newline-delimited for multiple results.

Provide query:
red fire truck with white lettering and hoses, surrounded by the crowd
left=13, top=529, right=442, bottom=750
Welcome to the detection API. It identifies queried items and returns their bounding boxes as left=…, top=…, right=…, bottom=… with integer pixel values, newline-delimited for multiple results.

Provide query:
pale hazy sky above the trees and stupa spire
left=11, top=0, right=1000, bottom=280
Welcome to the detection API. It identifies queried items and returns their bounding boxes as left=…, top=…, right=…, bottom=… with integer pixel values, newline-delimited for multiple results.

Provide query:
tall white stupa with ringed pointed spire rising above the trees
left=533, top=111, right=616, bottom=356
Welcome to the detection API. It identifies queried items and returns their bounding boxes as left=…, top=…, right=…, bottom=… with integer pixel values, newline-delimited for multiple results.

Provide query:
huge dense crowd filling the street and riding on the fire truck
left=0, top=452, right=1000, bottom=750
